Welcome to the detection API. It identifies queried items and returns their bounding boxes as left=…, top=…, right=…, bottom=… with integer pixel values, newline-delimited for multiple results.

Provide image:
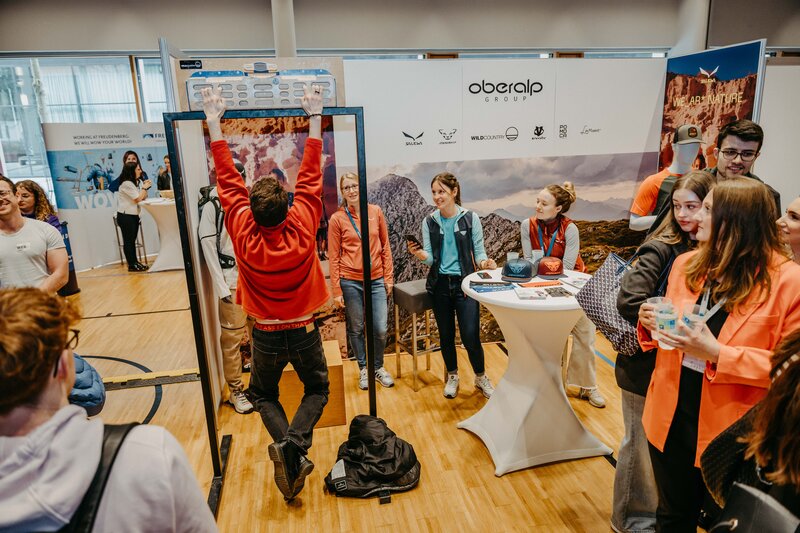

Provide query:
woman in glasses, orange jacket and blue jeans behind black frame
left=328, top=172, right=394, bottom=390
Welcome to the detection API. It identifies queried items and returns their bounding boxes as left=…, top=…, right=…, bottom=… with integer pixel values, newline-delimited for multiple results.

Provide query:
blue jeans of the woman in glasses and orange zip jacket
left=339, top=278, right=389, bottom=370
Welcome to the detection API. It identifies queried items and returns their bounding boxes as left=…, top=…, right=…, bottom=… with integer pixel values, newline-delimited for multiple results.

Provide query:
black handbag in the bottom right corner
left=708, top=483, right=800, bottom=533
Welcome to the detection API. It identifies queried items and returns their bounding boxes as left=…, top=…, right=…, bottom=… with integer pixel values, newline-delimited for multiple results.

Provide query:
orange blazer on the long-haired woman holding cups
left=638, top=252, right=800, bottom=467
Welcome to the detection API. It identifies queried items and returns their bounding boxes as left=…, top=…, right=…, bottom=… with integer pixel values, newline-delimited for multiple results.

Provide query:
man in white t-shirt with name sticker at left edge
left=0, top=175, right=69, bottom=293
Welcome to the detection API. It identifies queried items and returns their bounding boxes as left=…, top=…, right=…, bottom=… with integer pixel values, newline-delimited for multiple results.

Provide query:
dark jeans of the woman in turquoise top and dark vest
left=433, top=274, right=484, bottom=374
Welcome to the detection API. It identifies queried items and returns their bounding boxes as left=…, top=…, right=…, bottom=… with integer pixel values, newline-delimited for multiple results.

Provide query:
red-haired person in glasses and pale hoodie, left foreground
left=0, top=288, right=217, bottom=532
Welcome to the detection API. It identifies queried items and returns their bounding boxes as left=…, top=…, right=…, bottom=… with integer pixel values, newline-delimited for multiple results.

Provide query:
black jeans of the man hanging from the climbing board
left=250, top=324, right=329, bottom=452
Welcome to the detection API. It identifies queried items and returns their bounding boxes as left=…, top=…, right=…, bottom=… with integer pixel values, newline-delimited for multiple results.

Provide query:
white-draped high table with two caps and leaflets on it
left=458, top=269, right=612, bottom=476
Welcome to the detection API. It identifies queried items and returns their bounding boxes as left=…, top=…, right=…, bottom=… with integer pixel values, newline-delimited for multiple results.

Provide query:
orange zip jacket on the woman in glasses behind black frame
left=328, top=204, right=394, bottom=296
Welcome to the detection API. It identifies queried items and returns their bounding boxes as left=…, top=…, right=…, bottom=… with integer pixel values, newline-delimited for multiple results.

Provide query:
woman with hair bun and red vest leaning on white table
left=520, top=181, right=606, bottom=407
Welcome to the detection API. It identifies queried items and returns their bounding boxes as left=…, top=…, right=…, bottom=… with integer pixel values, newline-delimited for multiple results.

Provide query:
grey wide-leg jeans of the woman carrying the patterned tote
left=611, top=388, right=658, bottom=533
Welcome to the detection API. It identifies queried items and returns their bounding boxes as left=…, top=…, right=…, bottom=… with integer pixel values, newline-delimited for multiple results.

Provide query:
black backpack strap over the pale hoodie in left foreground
left=59, top=422, right=139, bottom=533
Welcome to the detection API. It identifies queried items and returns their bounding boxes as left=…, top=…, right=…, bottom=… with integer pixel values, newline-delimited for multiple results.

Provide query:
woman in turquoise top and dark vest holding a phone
left=408, top=172, right=497, bottom=398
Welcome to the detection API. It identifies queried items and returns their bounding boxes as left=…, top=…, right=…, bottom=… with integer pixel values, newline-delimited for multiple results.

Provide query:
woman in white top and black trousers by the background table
left=117, top=161, right=152, bottom=272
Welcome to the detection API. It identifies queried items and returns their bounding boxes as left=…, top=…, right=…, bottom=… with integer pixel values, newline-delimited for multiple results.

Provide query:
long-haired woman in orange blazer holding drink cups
left=639, top=178, right=800, bottom=533
